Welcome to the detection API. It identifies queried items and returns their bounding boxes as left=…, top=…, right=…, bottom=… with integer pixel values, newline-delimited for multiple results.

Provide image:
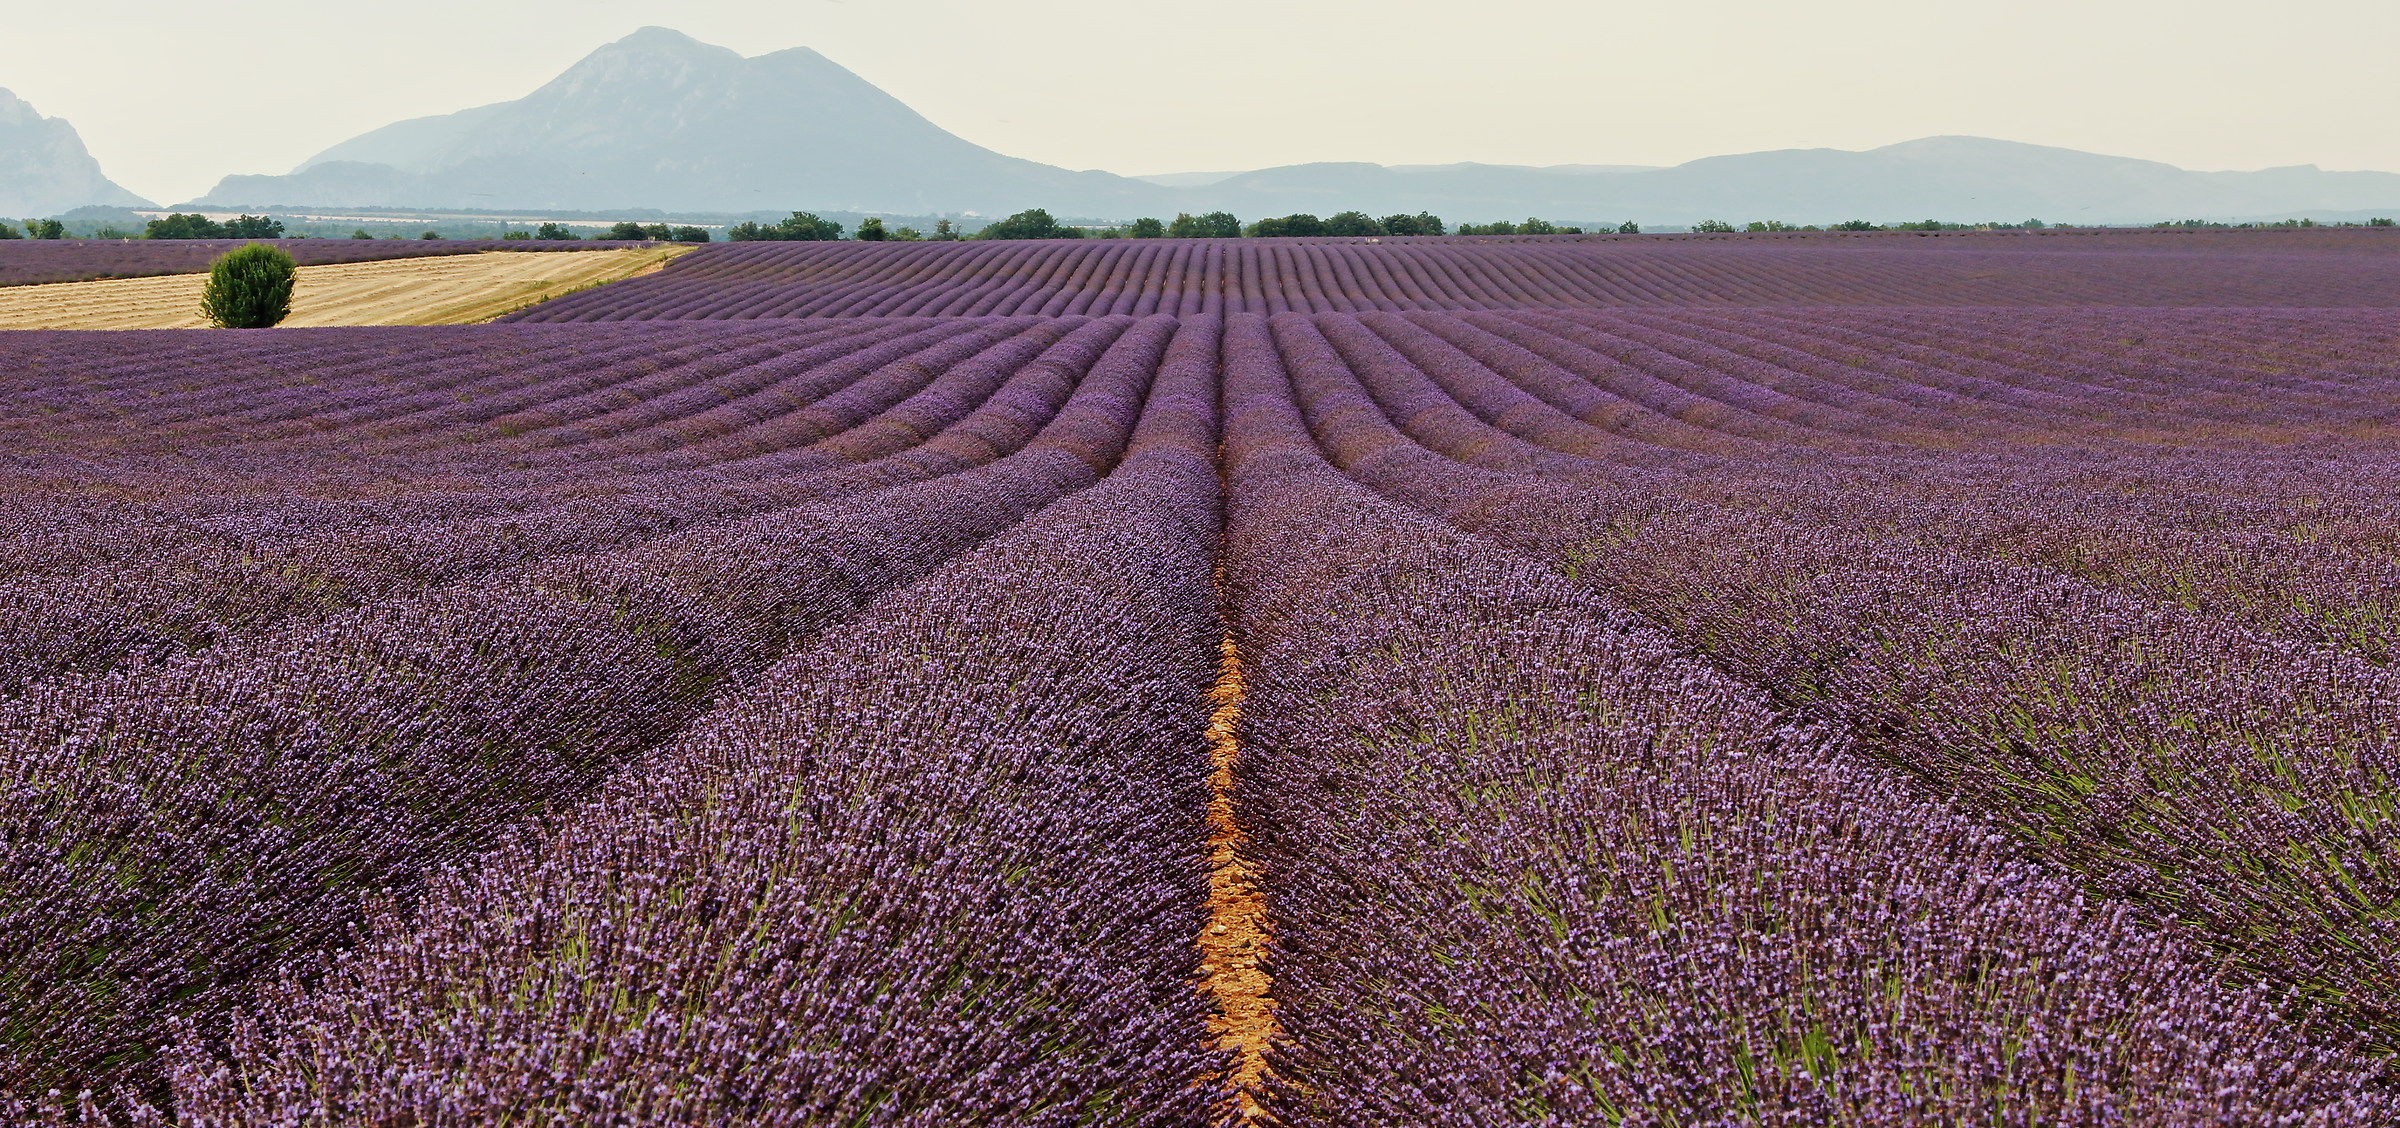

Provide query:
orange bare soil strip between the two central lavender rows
left=1200, top=636, right=1282, bottom=1123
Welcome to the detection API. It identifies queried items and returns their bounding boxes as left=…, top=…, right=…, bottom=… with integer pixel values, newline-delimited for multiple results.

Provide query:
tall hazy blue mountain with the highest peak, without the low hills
left=192, top=26, right=1164, bottom=216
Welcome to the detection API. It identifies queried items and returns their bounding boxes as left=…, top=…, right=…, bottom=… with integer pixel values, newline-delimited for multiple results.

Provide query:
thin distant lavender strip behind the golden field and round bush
left=0, top=240, right=638, bottom=286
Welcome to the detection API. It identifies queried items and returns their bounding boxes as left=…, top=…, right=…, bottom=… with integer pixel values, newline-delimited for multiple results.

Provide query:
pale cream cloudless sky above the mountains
left=0, top=0, right=2400, bottom=204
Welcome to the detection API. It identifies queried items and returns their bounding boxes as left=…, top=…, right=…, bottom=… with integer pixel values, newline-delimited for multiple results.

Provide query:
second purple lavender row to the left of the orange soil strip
left=0, top=312, right=1162, bottom=1092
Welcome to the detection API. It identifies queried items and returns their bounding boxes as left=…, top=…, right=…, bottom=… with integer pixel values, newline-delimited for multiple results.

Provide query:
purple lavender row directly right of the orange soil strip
left=1226, top=334, right=2400, bottom=1126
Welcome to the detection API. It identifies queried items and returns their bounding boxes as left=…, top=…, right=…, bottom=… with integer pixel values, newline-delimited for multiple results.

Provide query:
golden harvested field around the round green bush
left=0, top=245, right=691, bottom=329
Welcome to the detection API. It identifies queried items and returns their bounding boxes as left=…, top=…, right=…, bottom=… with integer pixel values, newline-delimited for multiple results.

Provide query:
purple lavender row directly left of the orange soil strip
left=126, top=324, right=1226, bottom=1126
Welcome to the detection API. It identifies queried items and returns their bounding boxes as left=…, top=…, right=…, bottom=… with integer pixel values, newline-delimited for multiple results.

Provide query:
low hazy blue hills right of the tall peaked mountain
left=1154, top=137, right=2400, bottom=223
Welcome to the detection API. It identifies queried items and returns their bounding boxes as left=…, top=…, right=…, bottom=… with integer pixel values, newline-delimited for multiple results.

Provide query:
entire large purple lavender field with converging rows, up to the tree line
left=0, top=233, right=2400, bottom=1128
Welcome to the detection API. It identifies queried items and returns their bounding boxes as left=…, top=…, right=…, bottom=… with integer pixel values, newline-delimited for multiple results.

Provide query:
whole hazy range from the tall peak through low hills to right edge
left=190, top=26, right=2400, bottom=226
